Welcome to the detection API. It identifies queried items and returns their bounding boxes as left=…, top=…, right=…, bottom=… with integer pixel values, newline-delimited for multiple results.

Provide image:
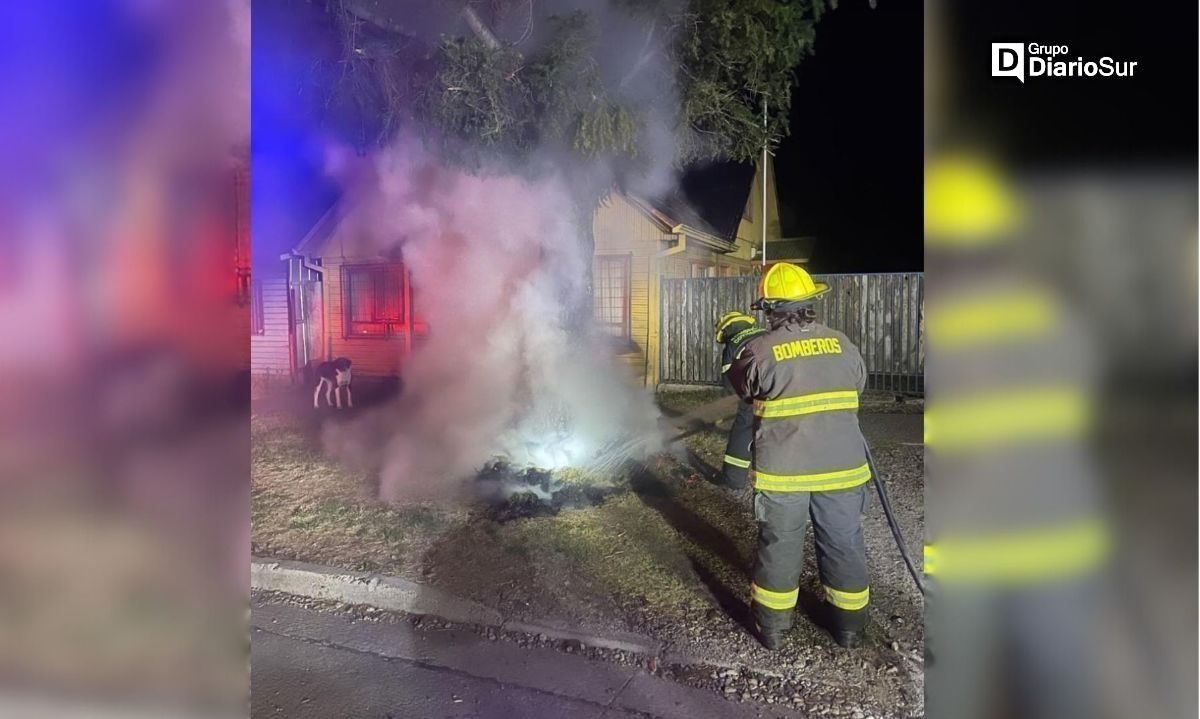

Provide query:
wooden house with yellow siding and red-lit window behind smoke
left=251, top=163, right=806, bottom=385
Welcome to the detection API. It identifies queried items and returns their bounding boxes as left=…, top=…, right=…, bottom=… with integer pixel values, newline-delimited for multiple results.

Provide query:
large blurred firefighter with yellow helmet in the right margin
left=925, top=154, right=1109, bottom=719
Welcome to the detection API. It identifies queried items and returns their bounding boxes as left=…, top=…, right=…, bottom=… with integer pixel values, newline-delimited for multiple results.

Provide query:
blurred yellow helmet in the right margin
left=925, top=155, right=1020, bottom=247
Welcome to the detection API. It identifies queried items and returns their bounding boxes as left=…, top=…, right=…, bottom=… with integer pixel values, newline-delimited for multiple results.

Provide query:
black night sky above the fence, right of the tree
left=775, top=0, right=923, bottom=272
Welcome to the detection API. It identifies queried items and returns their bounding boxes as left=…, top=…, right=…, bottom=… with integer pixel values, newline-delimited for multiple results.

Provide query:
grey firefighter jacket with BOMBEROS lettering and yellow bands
left=728, top=323, right=871, bottom=492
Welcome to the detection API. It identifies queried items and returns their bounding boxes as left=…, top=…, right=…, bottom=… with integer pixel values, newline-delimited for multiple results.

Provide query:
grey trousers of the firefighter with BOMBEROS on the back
left=751, top=484, right=870, bottom=631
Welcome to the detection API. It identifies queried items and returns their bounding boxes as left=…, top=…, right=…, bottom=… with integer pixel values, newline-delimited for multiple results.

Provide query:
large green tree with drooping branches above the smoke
left=309, top=0, right=854, bottom=314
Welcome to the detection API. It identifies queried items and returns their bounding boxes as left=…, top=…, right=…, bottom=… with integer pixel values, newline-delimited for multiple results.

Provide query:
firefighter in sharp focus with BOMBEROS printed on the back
left=728, top=263, right=871, bottom=649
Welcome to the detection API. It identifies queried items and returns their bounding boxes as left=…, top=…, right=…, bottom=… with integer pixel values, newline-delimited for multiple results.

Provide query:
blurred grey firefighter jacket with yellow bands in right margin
left=925, top=271, right=1112, bottom=586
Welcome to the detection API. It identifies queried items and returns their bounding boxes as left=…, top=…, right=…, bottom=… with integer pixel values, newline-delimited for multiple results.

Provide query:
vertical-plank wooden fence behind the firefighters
left=659, top=272, right=925, bottom=394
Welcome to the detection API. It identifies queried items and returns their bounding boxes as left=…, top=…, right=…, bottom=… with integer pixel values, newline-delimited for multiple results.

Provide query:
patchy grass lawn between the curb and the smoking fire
left=251, top=391, right=754, bottom=615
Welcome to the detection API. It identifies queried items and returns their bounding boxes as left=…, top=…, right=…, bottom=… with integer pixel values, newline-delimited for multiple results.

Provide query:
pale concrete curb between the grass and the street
left=250, top=557, right=664, bottom=657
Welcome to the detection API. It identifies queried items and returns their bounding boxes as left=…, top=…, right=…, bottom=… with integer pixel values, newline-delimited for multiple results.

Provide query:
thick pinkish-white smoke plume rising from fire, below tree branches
left=325, top=138, right=658, bottom=501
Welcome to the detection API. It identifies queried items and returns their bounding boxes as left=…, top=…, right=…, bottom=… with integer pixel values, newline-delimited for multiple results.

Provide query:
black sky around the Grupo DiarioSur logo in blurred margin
left=947, top=0, right=1198, bottom=173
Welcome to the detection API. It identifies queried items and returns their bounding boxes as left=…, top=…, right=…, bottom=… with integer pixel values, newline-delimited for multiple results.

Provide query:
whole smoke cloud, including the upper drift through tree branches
left=314, top=0, right=700, bottom=499
